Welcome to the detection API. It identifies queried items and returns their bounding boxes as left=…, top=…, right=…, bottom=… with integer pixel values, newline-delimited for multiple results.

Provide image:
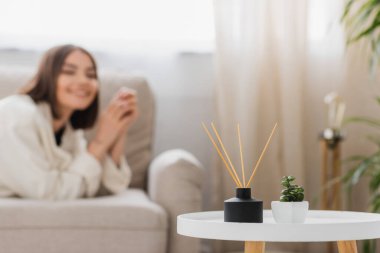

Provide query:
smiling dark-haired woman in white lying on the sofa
left=0, top=45, right=138, bottom=199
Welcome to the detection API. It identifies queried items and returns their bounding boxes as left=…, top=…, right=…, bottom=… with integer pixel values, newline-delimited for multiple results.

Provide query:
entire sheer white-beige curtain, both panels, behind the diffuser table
left=214, top=0, right=360, bottom=252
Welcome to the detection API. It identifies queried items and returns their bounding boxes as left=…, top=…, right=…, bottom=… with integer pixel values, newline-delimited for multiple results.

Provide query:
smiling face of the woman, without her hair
left=56, top=50, right=98, bottom=113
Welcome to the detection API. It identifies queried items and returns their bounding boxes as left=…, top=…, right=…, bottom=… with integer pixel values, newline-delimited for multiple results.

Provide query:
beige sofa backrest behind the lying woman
left=0, top=67, right=154, bottom=189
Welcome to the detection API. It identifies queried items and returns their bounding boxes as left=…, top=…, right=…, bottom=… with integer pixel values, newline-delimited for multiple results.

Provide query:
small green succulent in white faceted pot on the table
left=271, top=176, right=309, bottom=223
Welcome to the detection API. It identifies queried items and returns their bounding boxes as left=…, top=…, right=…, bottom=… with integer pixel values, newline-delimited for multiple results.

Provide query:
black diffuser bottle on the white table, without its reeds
left=224, top=188, right=263, bottom=223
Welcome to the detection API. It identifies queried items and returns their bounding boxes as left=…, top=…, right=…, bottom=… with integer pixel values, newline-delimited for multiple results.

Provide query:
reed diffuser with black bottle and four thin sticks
left=202, top=123, right=277, bottom=223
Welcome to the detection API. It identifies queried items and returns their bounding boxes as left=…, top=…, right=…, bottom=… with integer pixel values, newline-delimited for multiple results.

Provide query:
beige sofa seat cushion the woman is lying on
left=0, top=189, right=167, bottom=231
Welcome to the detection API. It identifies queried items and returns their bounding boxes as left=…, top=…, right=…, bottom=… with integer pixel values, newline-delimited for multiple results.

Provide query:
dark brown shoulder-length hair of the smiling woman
left=23, top=45, right=99, bottom=129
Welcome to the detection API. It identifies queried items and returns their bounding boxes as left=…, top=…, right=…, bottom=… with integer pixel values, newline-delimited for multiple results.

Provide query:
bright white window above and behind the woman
left=0, top=0, right=214, bottom=51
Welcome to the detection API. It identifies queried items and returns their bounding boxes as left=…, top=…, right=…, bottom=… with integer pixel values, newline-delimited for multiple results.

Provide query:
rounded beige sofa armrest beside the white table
left=148, top=149, right=204, bottom=253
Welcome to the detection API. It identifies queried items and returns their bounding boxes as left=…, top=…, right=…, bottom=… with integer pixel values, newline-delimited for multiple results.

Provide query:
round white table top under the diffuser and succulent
left=177, top=210, right=380, bottom=242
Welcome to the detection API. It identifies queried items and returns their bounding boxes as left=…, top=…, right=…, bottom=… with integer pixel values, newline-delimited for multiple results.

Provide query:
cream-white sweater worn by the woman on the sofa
left=0, top=95, right=131, bottom=200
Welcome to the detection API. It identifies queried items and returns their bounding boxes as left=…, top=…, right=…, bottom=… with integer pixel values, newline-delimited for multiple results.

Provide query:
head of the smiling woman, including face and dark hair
left=25, top=46, right=98, bottom=131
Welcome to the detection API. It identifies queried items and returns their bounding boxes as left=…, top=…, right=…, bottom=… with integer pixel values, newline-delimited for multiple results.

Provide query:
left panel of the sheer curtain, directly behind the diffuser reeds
left=215, top=0, right=307, bottom=207
